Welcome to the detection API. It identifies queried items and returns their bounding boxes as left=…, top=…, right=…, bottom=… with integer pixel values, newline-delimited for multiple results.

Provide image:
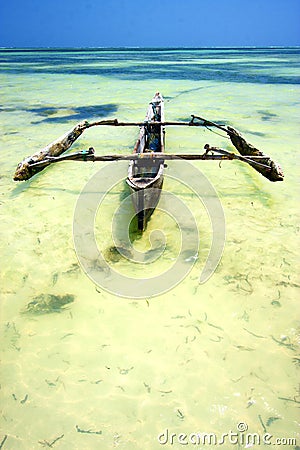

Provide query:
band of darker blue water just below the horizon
left=0, top=48, right=300, bottom=84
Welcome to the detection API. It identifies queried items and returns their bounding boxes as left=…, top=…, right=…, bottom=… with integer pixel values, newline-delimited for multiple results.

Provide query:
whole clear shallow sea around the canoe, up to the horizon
left=0, top=48, right=300, bottom=450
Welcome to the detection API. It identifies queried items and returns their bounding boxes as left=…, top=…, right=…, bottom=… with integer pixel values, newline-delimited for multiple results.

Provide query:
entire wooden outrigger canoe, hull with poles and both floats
left=14, top=92, right=284, bottom=231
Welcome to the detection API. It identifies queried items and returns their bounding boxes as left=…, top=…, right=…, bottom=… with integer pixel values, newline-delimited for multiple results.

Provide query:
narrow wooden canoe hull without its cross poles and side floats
left=126, top=92, right=165, bottom=231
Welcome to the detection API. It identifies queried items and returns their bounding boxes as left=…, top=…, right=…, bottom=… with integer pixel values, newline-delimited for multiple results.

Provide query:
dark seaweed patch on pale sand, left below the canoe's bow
left=22, top=294, right=75, bottom=315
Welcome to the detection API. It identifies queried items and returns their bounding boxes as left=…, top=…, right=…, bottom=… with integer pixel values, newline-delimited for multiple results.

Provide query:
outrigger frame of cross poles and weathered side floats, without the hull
left=14, top=119, right=284, bottom=181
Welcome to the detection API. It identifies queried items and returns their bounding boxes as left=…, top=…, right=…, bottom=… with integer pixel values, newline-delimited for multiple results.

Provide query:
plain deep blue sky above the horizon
left=0, top=0, right=300, bottom=47
